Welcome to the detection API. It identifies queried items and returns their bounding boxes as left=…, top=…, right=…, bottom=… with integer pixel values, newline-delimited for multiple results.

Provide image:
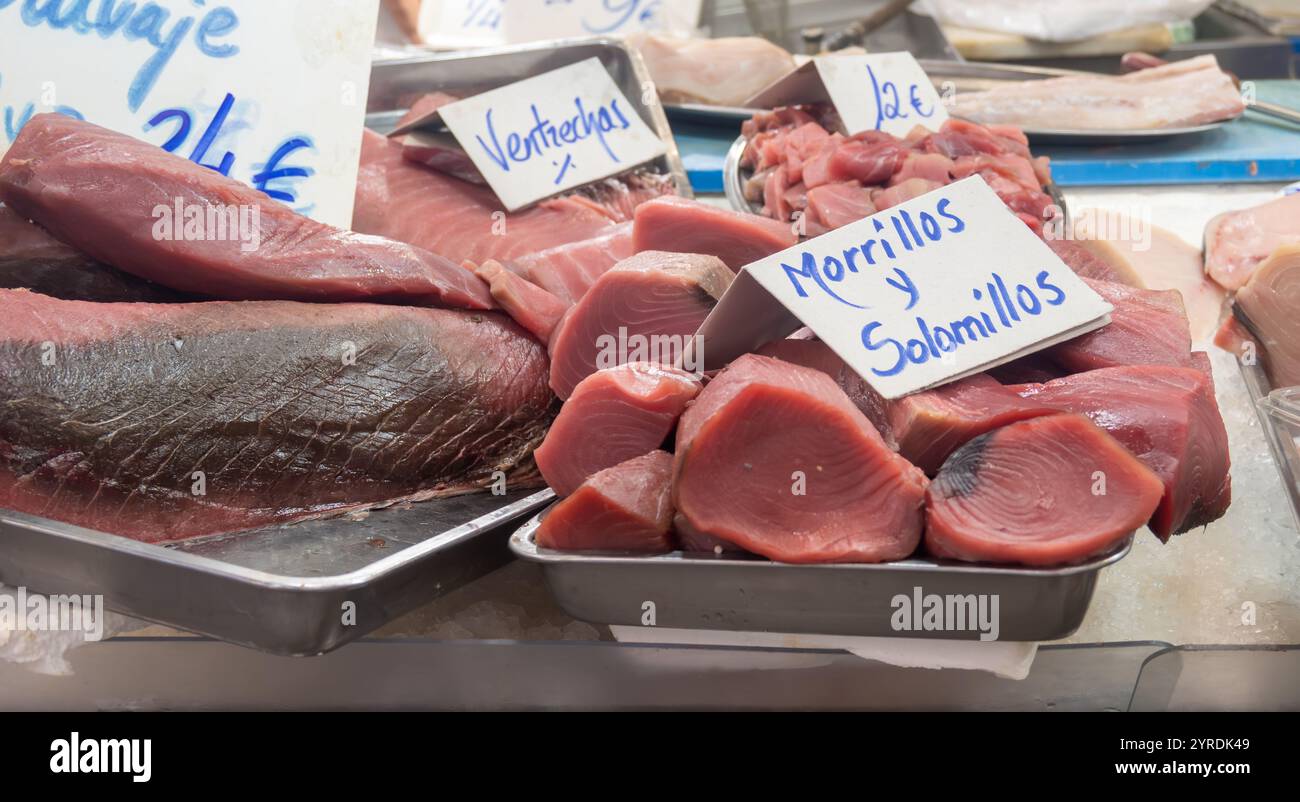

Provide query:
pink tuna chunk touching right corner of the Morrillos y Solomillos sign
left=1050, top=278, right=1192, bottom=373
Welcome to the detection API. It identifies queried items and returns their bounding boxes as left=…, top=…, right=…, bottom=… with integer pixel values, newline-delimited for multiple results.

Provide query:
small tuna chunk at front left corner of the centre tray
left=534, top=451, right=672, bottom=554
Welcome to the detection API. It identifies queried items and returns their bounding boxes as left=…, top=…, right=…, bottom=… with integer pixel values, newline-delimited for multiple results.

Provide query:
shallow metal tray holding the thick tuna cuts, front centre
left=510, top=513, right=1132, bottom=641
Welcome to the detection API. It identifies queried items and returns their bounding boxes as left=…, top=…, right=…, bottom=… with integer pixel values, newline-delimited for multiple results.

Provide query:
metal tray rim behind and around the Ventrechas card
left=365, top=39, right=694, bottom=198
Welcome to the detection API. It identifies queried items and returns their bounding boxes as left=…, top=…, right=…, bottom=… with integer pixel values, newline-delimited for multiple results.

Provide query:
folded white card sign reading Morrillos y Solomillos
left=699, top=175, right=1112, bottom=399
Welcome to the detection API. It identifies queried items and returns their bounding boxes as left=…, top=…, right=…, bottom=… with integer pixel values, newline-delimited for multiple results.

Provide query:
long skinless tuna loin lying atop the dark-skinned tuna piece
left=0, top=114, right=491, bottom=309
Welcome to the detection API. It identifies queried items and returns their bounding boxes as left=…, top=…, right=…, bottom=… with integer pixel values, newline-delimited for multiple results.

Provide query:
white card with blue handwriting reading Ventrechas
left=439, top=58, right=667, bottom=212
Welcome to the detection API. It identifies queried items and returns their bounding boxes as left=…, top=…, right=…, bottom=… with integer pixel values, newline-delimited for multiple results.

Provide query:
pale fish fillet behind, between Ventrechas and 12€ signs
left=628, top=34, right=794, bottom=105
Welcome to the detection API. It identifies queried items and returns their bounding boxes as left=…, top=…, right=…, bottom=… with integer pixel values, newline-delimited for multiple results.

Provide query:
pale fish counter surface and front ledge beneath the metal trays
left=0, top=185, right=1300, bottom=711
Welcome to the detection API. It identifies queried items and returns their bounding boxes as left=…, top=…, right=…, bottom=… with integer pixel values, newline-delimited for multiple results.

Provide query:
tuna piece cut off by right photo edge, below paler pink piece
left=1235, top=244, right=1300, bottom=387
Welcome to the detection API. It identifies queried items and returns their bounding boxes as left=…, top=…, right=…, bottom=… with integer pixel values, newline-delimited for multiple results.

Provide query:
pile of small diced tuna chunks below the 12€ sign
left=741, top=104, right=1054, bottom=237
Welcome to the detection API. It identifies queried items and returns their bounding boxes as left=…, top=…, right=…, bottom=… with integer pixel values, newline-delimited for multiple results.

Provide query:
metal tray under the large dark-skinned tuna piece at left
left=0, top=490, right=554, bottom=655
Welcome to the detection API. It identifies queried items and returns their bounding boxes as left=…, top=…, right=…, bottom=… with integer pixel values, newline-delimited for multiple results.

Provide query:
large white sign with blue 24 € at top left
left=0, top=0, right=378, bottom=227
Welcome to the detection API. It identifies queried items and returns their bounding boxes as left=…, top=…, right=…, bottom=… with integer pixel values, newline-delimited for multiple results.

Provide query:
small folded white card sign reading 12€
left=745, top=52, right=948, bottom=136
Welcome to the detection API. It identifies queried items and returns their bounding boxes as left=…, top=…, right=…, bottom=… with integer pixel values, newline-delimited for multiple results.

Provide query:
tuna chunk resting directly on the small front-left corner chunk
left=534, top=363, right=701, bottom=495
